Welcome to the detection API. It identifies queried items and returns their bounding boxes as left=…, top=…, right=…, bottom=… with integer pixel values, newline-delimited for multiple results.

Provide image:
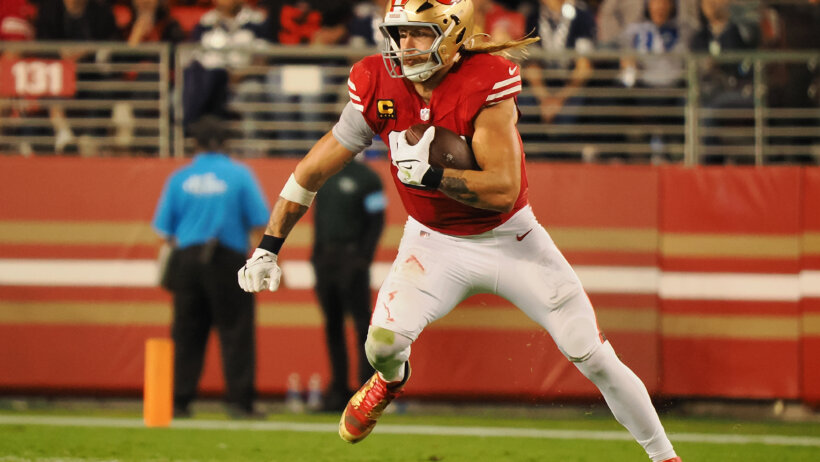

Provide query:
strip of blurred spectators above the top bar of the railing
left=0, top=0, right=818, bottom=52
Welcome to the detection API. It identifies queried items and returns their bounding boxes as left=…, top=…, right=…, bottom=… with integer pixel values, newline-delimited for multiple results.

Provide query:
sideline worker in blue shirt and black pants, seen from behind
left=153, top=116, right=270, bottom=418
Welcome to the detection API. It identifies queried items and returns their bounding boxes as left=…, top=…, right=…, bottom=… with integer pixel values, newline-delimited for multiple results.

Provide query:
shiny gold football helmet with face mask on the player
left=379, top=0, right=473, bottom=82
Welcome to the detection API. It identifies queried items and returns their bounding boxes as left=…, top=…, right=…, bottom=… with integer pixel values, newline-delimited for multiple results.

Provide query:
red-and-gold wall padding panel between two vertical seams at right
left=660, top=168, right=801, bottom=398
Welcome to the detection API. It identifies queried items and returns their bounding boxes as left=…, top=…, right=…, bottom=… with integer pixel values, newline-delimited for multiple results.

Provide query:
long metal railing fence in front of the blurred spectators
left=0, top=43, right=820, bottom=165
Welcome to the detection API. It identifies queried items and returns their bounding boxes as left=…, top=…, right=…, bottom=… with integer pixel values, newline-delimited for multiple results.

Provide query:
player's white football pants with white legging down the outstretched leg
left=371, top=206, right=674, bottom=461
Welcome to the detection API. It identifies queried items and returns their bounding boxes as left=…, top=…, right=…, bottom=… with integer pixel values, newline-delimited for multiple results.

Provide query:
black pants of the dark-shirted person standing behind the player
left=314, top=258, right=373, bottom=401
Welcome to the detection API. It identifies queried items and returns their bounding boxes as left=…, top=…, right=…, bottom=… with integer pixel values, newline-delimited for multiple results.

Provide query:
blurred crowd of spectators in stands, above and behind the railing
left=0, top=0, right=820, bottom=162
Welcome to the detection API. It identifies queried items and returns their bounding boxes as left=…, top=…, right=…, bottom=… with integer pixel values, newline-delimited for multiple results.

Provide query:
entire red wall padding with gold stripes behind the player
left=0, top=158, right=820, bottom=400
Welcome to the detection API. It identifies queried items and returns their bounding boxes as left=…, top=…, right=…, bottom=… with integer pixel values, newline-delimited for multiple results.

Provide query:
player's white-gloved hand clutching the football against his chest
left=390, top=126, right=443, bottom=189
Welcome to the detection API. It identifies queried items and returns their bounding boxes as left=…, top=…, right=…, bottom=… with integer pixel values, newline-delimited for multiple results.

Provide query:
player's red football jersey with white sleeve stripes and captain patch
left=348, top=53, right=527, bottom=236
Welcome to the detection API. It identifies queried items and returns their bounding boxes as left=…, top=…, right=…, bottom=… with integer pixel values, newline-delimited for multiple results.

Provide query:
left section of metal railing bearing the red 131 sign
left=0, top=42, right=171, bottom=156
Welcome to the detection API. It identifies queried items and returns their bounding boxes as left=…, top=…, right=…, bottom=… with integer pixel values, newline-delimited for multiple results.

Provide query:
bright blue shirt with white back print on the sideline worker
left=153, top=152, right=270, bottom=254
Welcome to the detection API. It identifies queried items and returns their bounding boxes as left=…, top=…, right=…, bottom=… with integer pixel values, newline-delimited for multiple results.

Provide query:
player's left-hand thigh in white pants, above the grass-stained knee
left=371, top=227, right=467, bottom=340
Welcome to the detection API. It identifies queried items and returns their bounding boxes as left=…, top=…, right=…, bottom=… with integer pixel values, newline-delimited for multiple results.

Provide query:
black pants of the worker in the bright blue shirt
left=171, top=245, right=256, bottom=411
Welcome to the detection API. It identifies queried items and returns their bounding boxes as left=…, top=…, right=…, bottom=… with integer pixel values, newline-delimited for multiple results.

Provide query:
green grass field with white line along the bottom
left=0, top=400, right=820, bottom=462
